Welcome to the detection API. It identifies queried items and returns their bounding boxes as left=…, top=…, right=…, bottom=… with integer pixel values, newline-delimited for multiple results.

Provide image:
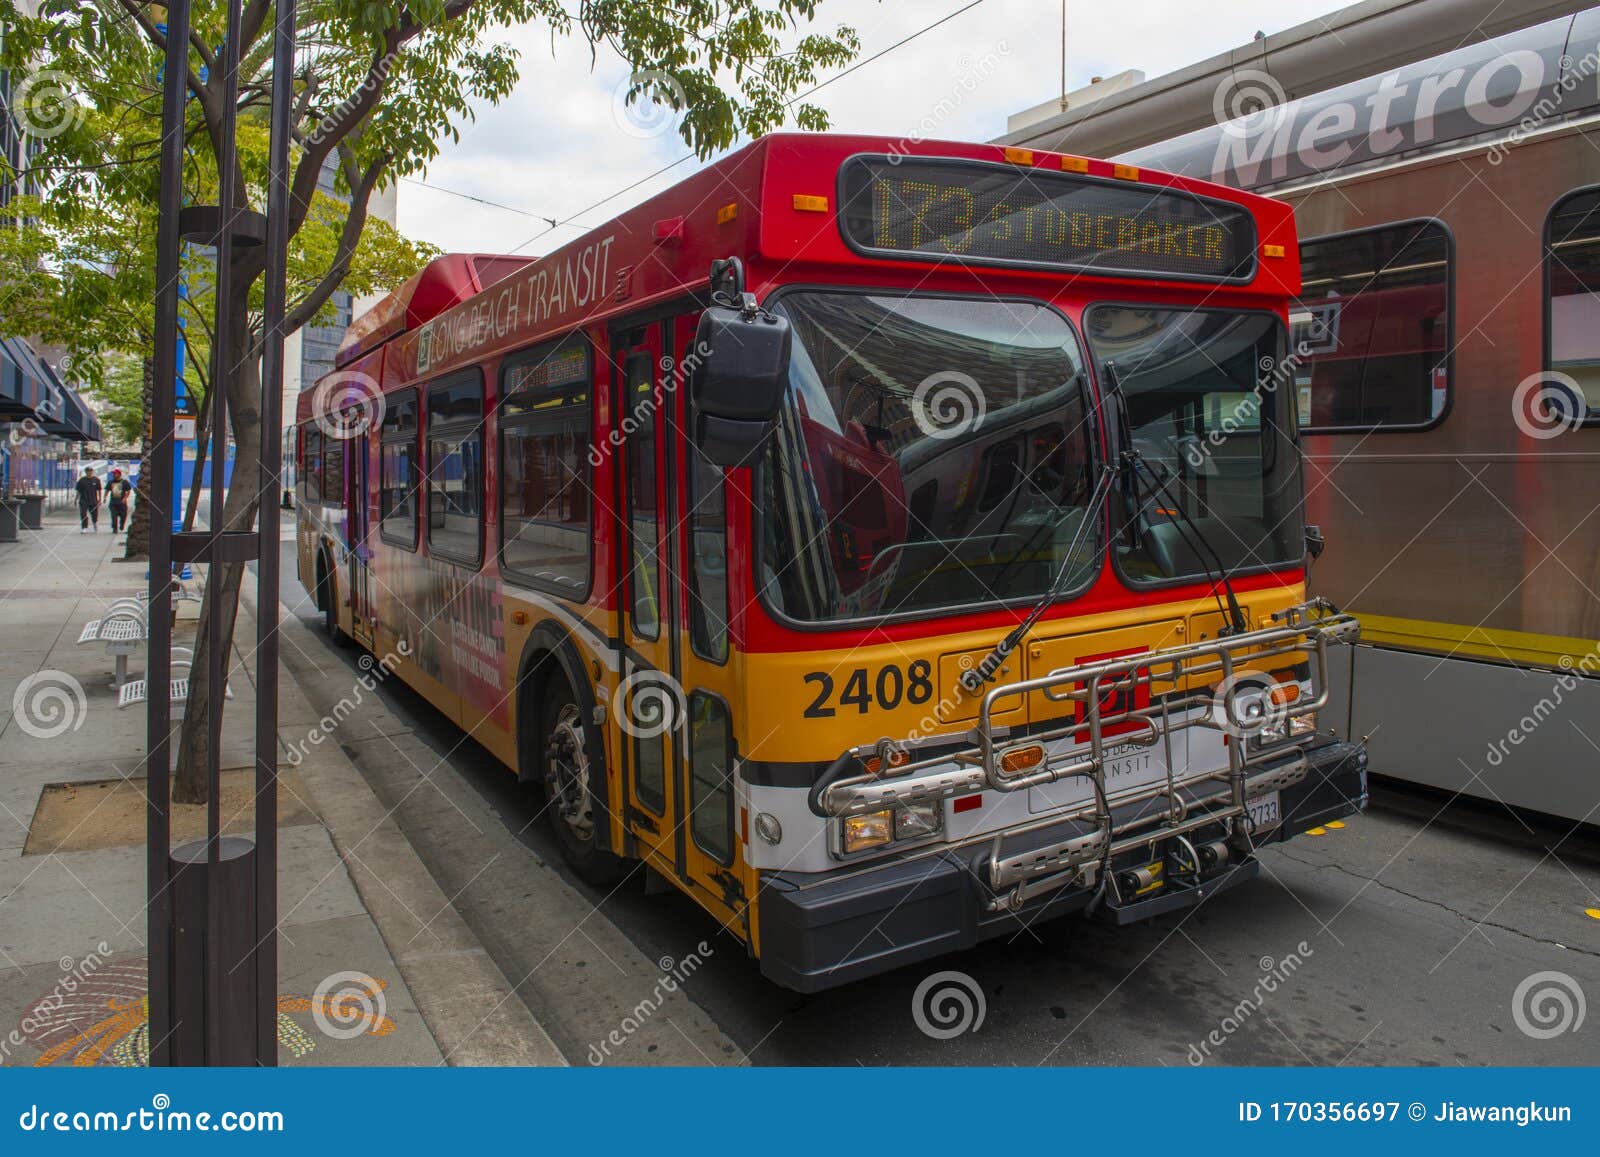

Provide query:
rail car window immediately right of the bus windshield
left=1290, top=221, right=1451, bottom=430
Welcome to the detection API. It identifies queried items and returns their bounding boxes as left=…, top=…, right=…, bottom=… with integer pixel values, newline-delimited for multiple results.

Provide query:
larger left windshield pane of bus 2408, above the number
left=758, top=290, right=1101, bottom=623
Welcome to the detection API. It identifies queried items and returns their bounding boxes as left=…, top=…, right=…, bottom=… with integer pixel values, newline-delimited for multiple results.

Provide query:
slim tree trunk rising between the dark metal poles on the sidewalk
left=173, top=278, right=262, bottom=803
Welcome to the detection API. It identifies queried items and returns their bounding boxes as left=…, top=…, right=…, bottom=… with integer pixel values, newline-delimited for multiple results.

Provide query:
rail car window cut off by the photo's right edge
left=1539, top=189, right=1600, bottom=429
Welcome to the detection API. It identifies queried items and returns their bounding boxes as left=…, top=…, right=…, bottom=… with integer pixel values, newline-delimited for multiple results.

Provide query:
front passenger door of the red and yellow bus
left=613, top=312, right=738, bottom=920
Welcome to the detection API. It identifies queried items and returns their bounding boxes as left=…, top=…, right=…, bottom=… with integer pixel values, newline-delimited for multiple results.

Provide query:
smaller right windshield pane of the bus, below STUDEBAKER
left=1083, top=306, right=1304, bottom=583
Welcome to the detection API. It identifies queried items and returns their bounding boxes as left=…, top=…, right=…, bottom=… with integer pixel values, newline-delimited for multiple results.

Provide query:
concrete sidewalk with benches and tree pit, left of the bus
left=0, top=515, right=563, bottom=1064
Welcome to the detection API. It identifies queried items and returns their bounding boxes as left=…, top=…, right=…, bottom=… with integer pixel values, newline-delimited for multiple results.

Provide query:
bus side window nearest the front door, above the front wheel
left=501, top=341, right=592, bottom=597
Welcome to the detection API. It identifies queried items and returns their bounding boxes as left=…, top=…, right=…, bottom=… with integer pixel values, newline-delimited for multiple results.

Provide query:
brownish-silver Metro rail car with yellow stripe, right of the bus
left=1100, top=8, right=1600, bottom=824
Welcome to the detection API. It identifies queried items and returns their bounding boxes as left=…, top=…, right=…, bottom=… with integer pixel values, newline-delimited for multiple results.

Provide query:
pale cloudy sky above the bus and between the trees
left=398, top=0, right=1342, bottom=254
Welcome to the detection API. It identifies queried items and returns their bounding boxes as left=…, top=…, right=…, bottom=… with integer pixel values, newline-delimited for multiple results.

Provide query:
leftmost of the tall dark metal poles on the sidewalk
left=144, top=0, right=189, bottom=1066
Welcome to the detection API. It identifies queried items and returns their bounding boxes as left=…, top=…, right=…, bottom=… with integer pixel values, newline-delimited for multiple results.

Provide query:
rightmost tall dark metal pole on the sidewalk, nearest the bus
left=256, top=0, right=296, bottom=1066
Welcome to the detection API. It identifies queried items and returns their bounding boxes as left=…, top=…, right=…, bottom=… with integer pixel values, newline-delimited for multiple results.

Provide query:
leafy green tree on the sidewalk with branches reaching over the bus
left=0, top=0, right=859, bottom=802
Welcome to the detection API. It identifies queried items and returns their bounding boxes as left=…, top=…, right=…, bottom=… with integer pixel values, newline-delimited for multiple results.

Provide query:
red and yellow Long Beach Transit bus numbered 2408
left=296, top=134, right=1366, bottom=991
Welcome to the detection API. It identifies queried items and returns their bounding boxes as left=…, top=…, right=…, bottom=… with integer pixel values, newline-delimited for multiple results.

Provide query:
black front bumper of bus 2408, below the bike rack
left=758, top=741, right=1366, bottom=992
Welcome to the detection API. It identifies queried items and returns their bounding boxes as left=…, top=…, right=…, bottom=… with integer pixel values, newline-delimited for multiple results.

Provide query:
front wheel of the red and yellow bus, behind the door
left=538, top=674, right=627, bottom=888
